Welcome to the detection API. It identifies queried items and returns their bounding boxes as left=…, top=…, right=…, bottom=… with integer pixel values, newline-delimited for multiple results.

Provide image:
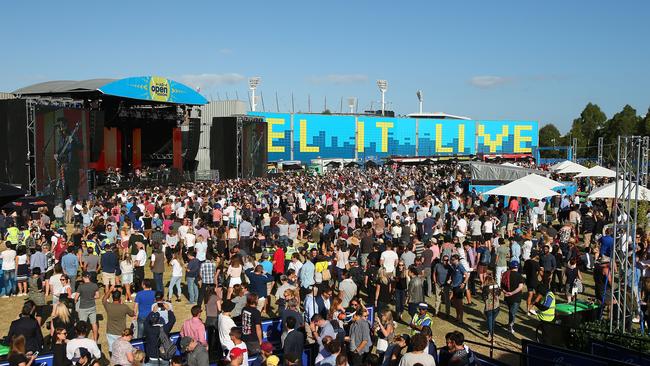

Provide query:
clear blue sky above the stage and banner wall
left=0, top=0, right=650, bottom=132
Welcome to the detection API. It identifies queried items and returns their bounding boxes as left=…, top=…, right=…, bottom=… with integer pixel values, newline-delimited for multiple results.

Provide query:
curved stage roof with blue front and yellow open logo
left=13, top=76, right=208, bottom=105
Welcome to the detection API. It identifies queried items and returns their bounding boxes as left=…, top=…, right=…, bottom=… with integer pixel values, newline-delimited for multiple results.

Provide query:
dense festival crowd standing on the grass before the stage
left=0, top=165, right=650, bottom=366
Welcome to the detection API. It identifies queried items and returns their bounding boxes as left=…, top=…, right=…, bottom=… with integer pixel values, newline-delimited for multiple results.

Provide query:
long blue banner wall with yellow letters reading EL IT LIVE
left=249, top=112, right=538, bottom=163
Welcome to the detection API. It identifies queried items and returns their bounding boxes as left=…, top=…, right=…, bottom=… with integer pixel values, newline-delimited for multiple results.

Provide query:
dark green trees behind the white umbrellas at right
left=539, top=103, right=650, bottom=163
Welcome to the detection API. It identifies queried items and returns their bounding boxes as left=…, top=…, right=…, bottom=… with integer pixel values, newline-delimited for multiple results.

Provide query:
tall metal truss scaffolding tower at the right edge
left=609, top=136, right=649, bottom=331
